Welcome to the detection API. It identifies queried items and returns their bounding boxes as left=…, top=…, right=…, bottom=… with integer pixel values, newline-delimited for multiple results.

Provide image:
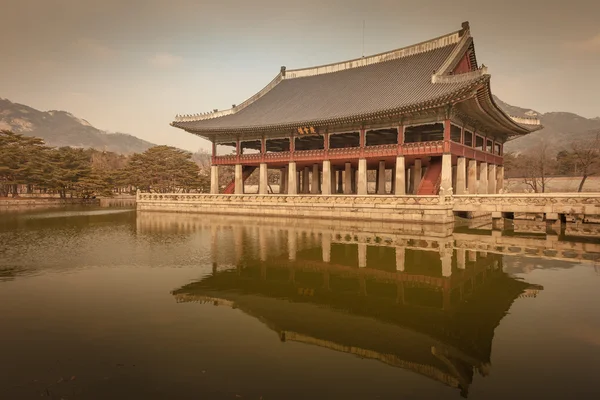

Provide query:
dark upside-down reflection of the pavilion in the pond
left=173, top=223, right=539, bottom=395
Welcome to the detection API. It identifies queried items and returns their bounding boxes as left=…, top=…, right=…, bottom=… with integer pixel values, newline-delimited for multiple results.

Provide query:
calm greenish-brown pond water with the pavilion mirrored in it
left=0, top=208, right=600, bottom=400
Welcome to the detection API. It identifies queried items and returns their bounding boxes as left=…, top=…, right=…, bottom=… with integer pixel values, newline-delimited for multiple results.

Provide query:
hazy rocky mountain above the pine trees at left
left=0, top=98, right=155, bottom=154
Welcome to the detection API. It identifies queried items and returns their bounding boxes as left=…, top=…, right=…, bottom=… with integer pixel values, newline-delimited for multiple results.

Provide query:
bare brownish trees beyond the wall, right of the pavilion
left=504, top=132, right=600, bottom=193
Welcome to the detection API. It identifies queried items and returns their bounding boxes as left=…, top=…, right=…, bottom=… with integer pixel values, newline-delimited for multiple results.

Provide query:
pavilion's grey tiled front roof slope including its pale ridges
left=172, top=25, right=502, bottom=133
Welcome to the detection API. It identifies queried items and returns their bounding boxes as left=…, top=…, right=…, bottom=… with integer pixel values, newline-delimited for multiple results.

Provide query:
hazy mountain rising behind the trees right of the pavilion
left=494, top=96, right=600, bottom=153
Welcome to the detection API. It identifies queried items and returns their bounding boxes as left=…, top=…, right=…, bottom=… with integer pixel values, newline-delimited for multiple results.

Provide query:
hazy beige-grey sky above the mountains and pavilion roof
left=0, top=0, right=600, bottom=151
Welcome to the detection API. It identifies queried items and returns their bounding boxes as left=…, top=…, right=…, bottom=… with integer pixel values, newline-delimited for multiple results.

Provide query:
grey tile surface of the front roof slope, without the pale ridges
left=173, top=45, right=477, bottom=131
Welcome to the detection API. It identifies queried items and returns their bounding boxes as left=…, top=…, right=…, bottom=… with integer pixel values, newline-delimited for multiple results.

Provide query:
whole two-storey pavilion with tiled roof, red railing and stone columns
left=171, top=22, right=541, bottom=195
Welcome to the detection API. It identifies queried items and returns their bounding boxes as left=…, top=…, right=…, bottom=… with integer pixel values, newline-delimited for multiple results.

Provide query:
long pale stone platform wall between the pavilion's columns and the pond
left=137, top=193, right=454, bottom=223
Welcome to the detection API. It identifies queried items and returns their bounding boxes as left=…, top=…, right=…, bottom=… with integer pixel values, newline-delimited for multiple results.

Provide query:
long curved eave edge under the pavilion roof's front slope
left=171, top=75, right=489, bottom=137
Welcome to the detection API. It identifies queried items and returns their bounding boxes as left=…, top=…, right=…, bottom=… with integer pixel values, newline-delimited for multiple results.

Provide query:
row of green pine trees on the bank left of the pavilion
left=0, top=130, right=210, bottom=198
